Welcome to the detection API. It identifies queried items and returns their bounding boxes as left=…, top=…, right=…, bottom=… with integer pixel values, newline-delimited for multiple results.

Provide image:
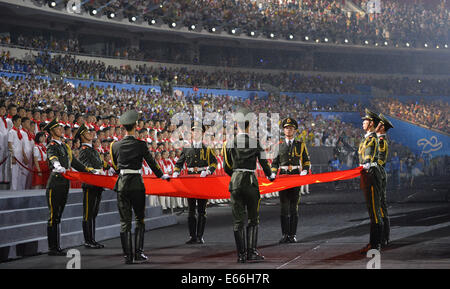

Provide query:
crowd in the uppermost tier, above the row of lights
left=51, top=0, right=449, bottom=47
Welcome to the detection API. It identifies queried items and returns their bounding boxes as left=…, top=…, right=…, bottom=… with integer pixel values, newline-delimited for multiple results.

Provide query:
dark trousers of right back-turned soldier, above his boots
left=230, top=185, right=261, bottom=231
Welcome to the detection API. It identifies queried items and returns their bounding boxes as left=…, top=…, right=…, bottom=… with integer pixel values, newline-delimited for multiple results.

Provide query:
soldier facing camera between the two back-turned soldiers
left=172, top=123, right=217, bottom=244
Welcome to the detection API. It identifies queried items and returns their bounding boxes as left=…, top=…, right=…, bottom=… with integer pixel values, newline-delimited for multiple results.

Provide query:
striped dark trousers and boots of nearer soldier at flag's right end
left=361, top=167, right=383, bottom=248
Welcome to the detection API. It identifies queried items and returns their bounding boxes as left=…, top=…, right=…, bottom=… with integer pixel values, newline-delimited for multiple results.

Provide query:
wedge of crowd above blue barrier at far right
left=373, top=97, right=450, bottom=134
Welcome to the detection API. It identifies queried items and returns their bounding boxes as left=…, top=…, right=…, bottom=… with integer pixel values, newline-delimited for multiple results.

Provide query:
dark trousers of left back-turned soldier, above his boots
left=117, top=191, right=145, bottom=233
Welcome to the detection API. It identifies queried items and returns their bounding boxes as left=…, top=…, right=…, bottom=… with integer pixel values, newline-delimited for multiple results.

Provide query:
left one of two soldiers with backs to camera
left=110, top=110, right=169, bottom=264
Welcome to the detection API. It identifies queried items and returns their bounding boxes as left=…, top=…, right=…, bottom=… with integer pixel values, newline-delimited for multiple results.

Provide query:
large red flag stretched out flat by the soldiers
left=64, top=167, right=362, bottom=199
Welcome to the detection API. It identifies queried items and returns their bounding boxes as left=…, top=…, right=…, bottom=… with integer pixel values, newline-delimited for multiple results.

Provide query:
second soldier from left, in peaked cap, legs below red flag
left=74, top=124, right=109, bottom=249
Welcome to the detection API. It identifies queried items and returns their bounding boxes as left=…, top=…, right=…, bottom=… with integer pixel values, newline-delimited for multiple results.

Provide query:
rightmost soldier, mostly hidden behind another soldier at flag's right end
left=376, top=113, right=394, bottom=247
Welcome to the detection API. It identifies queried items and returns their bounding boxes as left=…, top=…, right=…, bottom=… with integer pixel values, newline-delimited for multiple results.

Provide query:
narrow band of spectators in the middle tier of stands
left=0, top=51, right=450, bottom=96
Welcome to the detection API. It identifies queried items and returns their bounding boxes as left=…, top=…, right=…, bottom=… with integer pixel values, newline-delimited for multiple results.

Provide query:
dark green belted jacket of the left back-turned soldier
left=109, top=136, right=164, bottom=192
